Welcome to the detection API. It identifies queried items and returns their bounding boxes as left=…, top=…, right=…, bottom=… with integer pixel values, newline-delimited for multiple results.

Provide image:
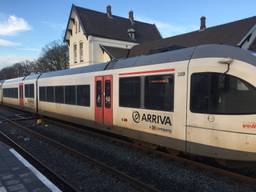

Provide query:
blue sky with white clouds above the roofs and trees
left=0, top=0, right=256, bottom=69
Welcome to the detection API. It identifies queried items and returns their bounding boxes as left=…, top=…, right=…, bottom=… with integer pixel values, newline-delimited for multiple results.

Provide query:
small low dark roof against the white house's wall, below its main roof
left=100, top=45, right=129, bottom=59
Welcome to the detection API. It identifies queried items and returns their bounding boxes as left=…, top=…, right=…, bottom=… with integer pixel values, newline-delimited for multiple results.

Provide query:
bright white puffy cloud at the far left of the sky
left=0, top=15, right=31, bottom=35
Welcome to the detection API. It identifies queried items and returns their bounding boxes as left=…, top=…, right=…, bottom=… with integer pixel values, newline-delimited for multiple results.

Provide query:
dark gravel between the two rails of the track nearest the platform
left=0, top=118, right=138, bottom=192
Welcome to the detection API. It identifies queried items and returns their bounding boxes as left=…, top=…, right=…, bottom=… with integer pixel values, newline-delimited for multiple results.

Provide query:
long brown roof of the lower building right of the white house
left=128, top=16, right=256, bottom=57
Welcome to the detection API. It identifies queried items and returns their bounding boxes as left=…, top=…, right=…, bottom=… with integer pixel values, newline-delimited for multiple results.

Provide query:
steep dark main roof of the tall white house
left=65, top=5, right=162, bottom=43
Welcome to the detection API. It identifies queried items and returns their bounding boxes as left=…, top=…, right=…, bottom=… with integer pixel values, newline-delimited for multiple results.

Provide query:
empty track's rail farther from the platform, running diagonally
left=0, top=111, right=159, bottom=192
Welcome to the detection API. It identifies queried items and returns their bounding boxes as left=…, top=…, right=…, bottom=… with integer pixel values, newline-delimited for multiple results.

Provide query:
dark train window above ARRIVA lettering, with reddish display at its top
left=144, top=75, right=174, bottom=111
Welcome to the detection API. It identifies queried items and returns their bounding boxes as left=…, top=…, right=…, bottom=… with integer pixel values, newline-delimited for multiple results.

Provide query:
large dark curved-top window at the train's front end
left=190, top=73, right=256, bottom=115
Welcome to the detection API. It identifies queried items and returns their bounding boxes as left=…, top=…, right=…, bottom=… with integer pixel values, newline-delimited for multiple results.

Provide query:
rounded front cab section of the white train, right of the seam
left=187, top=45, right=256, bottom=161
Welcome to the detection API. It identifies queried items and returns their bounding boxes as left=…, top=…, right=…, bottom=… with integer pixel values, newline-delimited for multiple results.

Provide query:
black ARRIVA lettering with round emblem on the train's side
left=132, top=111, right=172, bottom=126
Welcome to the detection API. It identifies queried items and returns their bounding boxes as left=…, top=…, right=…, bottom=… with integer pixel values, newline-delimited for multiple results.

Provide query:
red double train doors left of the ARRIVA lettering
left=95, top=75, right=113, bottom=125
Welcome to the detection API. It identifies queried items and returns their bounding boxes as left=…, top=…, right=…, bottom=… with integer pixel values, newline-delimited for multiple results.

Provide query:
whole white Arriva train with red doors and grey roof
left=0, top=44, right=256, bottom=162
